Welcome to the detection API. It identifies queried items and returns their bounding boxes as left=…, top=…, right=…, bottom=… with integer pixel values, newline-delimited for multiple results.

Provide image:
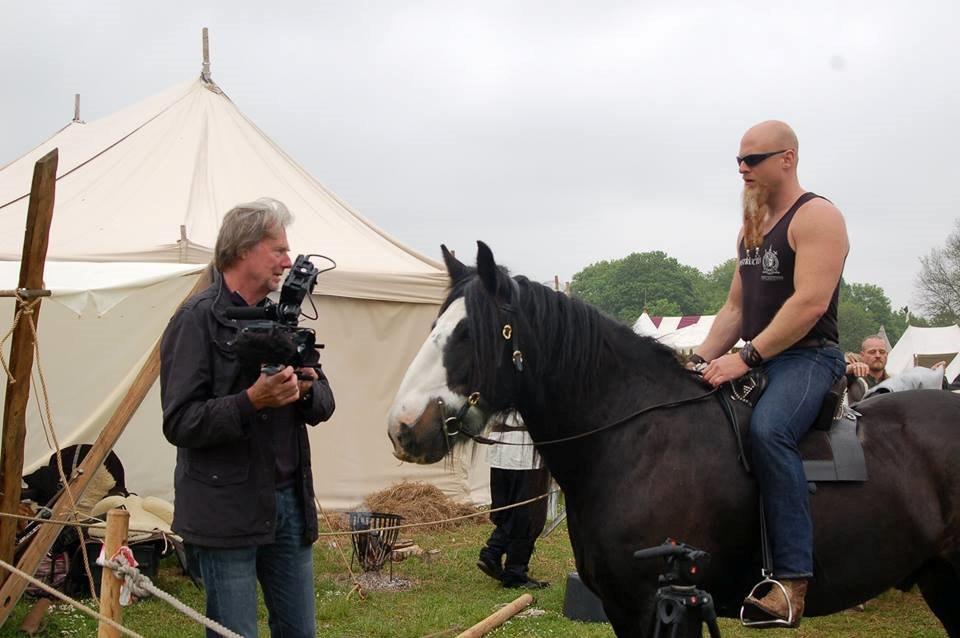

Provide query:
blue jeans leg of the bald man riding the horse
left=750, top=347, right=846, bottom=578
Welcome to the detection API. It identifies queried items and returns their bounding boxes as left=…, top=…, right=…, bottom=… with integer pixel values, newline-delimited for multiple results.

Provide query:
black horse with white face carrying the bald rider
left=389, top=243, right=960, bottom=637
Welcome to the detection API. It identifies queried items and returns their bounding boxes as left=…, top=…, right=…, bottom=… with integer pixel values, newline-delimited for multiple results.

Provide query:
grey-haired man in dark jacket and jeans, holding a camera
left=160, top=198, right=334, bottom=637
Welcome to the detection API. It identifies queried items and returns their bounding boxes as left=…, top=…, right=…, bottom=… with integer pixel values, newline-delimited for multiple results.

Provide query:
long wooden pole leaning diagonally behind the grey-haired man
left=0, top=268, right=211, bottom=627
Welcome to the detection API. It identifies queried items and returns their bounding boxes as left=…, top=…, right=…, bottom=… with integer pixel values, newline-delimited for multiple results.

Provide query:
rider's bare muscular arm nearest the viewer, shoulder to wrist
left=753, top=199, right=850, bottom=359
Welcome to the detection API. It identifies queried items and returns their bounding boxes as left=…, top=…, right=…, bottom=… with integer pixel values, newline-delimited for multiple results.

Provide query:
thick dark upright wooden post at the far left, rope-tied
left=0, top=149, right=58, bottom=576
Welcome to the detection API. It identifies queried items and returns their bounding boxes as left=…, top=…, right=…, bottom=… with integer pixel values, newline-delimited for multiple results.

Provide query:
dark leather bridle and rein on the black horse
left=437, top=277, right=719, bottom=447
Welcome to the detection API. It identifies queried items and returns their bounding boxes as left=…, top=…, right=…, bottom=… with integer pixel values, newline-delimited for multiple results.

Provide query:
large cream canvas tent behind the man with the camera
left=0, top=74, right=488, bottom=508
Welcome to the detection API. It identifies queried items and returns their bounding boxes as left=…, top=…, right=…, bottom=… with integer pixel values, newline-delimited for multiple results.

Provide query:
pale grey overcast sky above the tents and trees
left=0, top=0, right=960, bottom=306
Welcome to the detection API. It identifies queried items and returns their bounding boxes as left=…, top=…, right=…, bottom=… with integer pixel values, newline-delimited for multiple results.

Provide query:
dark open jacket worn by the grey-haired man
left=160, top=274, right=334, bottom=547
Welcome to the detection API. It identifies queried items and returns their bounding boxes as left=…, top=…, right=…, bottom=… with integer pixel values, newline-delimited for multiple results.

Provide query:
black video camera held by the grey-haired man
left=224, top=255, right=336, bottom=374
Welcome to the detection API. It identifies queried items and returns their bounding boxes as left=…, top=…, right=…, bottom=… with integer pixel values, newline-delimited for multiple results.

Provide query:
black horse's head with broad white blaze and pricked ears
left=388, top=242, right=525, bottom=463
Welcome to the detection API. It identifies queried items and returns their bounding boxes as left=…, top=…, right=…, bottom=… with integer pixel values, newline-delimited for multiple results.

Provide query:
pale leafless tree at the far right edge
left=917, top=219, right=960, bottom=325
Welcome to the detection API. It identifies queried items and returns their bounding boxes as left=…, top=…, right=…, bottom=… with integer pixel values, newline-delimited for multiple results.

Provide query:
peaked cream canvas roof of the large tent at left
left=0, top=79, right=446, bottom=303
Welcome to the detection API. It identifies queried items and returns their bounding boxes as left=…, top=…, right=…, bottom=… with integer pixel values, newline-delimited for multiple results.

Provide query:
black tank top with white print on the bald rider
left=739, top=193, right=840, bottom=343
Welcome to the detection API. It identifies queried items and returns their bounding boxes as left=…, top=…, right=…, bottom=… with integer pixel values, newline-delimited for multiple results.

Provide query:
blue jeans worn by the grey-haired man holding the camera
left=195, top=487, right=316, bottom=638
